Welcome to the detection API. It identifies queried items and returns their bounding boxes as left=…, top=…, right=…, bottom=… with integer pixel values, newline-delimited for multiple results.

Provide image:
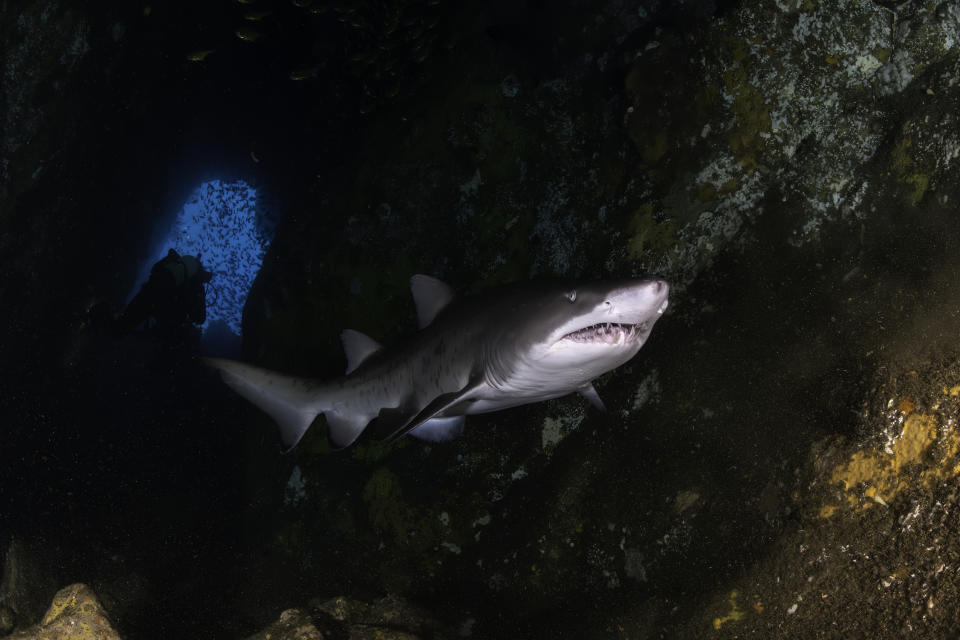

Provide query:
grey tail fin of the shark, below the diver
left=204, top=358, right=334, bottom=451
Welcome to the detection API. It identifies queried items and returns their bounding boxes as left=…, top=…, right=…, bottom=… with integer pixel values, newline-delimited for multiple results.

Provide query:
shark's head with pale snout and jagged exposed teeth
left=495, top=278, right=670, bottom=391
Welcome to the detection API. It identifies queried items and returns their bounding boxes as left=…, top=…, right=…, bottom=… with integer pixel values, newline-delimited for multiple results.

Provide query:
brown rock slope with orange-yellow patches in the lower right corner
left=684, top=359, right=960, bottom=638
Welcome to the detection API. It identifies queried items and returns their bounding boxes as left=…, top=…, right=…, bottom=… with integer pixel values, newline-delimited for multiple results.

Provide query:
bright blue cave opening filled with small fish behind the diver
left=130, top=180, right=276, bottom=348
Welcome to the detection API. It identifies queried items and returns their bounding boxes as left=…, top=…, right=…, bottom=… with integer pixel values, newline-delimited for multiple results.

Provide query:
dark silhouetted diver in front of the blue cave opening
left=116, top=249, right=213, bottom=337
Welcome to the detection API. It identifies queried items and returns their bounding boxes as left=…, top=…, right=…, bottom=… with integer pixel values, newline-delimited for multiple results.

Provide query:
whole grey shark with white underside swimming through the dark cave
left=205, top=275, right=670, bottom=451
